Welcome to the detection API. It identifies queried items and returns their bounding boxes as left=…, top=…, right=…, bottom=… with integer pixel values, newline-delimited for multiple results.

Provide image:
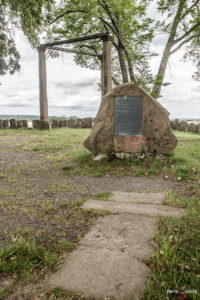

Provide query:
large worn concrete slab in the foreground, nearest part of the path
left=46, top=214, right=157, bottom=300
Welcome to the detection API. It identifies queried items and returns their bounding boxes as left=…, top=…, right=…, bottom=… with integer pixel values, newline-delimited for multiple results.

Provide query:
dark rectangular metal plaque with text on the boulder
left=115, top=96, right=143, bottom=136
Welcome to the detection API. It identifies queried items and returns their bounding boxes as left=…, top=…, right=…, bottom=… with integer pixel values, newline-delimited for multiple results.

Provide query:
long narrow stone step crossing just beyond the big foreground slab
left=82, top=200, right=184, bottom=217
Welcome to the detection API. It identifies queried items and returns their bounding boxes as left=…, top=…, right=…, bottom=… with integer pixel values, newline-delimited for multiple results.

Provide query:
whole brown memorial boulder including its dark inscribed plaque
left=84, top=83, right=177, bottom=155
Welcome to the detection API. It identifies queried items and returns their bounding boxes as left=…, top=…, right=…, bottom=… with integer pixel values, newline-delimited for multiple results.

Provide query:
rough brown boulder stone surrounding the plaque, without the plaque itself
left=84, top=83, right=177, bottom=154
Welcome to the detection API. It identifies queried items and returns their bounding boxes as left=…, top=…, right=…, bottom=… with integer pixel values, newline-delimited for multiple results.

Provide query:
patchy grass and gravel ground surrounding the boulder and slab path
left=0, top=128, right=200, bottom=300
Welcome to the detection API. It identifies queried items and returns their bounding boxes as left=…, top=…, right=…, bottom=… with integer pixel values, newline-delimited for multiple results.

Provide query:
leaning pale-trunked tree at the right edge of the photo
left=152, top=0, right=200, bottom=98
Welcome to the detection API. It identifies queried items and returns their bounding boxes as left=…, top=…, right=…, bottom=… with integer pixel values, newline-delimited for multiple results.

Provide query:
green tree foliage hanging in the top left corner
left=0, top=0, right=54, bottom=75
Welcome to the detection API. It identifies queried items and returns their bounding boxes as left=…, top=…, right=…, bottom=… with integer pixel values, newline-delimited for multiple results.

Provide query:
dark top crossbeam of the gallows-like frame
left=38, top=32, right=109, bottom=48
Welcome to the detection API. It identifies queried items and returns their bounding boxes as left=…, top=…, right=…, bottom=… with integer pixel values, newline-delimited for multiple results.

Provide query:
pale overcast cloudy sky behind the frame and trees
left=0, top=4, right=200, bottom=118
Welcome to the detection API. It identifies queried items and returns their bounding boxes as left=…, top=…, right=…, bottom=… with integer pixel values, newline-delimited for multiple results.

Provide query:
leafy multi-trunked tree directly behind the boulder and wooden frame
left=47, top=0, right=153, bottom=87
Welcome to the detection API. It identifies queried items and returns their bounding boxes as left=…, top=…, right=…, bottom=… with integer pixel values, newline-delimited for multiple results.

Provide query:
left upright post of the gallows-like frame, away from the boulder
left=38, top=48, right=48, bottom=121
